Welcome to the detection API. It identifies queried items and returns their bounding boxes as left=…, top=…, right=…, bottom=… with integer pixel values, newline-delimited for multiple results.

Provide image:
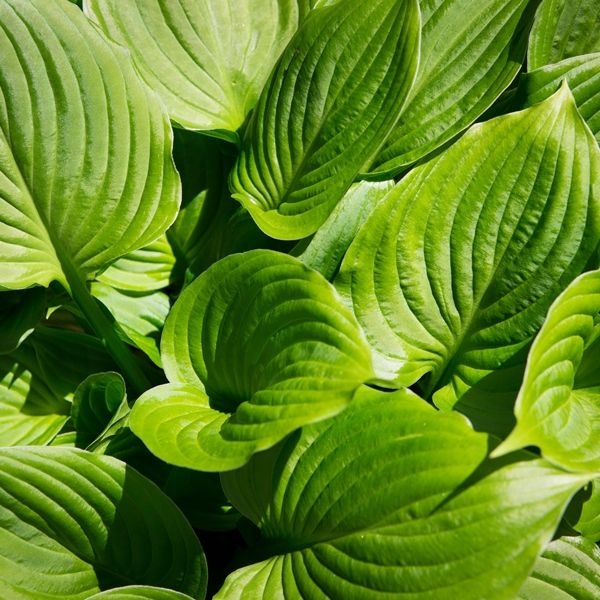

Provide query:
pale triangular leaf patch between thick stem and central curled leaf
left=92, top=282, right=171, bottom=366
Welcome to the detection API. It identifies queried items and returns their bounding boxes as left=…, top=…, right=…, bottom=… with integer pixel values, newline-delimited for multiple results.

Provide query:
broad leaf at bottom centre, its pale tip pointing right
left=216, top=390, right=586, bottom=600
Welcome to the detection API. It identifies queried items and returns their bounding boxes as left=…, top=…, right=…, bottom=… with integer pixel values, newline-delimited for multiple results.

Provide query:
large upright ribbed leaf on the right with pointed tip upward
left=336, top=86, right=600, bottom=420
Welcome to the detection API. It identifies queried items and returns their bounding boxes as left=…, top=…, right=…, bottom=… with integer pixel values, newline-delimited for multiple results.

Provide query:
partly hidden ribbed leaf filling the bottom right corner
left=517, top=537, right=600, bottom=600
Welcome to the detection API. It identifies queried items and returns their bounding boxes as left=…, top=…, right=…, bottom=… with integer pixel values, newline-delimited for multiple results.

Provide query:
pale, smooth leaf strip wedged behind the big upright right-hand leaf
left=299, top=181, right=394, bottom=281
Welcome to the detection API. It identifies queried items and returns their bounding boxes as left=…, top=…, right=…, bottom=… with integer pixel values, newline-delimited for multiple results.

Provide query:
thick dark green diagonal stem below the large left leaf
left=62, top=261, right=152, bottom=395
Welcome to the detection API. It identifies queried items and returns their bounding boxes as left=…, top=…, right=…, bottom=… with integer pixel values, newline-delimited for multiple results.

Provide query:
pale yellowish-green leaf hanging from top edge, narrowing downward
left=84, top=0, right=298, bottom=140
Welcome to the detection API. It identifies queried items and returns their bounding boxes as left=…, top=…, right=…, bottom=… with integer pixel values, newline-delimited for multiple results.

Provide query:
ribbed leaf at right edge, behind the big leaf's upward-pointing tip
left=515, top=52, right=600, bottom=142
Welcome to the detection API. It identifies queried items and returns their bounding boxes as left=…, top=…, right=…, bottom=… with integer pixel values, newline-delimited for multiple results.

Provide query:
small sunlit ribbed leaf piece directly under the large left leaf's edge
left=98, top=235, right=175, bottom=293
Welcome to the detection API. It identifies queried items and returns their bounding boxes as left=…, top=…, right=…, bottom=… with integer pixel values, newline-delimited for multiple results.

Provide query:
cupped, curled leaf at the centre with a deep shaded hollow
left=131, top=250, right=373, bottom=471
